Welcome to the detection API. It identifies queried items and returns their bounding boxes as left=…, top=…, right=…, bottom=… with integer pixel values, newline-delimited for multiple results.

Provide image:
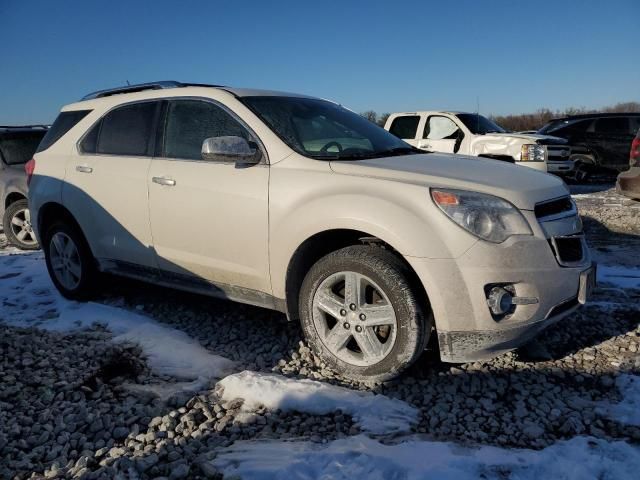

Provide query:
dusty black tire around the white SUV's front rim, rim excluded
left=299, top=246, right=433, bottom=383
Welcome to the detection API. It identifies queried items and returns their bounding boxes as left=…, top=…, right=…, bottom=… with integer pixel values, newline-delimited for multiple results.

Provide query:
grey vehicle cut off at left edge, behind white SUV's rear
left=0, top=125, right=48, bottom=250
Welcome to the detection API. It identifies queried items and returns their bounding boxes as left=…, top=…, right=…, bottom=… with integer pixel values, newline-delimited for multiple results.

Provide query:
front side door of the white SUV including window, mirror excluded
left=148, top=99, right=271, bottom=296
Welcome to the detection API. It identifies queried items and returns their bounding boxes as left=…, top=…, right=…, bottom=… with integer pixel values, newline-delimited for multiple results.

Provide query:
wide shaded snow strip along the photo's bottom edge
left=212, top=436, right=640, bottom=480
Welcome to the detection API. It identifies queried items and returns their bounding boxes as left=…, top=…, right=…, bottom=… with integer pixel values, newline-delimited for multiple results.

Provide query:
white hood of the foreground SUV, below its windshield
left=330, top=153, right=569, bottom=210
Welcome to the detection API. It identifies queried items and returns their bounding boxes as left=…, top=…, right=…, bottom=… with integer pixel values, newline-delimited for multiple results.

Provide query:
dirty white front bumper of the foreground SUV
left=407, top=213, right=591, bottom=363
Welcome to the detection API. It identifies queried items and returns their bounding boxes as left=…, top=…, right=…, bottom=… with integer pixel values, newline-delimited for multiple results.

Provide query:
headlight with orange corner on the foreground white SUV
left=431, top=189, right=533, bottom=243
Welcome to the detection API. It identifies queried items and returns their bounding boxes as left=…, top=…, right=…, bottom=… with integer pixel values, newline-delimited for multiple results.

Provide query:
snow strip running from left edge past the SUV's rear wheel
left=0, top=252, right=234, bottom=380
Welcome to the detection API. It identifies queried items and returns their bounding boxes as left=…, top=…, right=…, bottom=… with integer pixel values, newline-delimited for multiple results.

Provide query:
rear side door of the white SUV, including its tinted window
left=63, top=101, right=161, bottom=269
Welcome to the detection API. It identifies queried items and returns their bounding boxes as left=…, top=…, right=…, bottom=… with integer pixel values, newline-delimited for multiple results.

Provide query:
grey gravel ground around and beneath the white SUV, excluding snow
left=0, top=186, right=640, bottom=478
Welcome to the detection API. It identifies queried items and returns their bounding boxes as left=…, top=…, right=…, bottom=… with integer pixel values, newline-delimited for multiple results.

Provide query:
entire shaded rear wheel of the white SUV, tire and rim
left=43, top=222, right=97, bottom=300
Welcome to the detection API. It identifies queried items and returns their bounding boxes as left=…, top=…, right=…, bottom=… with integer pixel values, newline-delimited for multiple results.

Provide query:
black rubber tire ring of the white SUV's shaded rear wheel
left=42, top=221, right=98, bottom=300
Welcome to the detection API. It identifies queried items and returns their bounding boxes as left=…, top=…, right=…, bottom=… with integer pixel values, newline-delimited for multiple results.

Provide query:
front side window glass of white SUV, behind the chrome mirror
left=164, top=100, right=251, bottom=160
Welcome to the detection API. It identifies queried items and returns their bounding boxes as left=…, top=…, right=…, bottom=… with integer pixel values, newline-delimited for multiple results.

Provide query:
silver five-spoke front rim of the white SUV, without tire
left=312, top=272, right=398, bottom=367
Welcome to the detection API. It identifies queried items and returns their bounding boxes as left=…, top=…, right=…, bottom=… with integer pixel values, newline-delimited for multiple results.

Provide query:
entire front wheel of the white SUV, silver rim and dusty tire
left=300, top=246, right=432, bottom=383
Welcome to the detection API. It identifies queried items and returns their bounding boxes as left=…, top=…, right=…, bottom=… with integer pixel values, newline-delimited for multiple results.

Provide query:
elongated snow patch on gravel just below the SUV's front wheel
left=218, top=371, right=418, bottom=434
